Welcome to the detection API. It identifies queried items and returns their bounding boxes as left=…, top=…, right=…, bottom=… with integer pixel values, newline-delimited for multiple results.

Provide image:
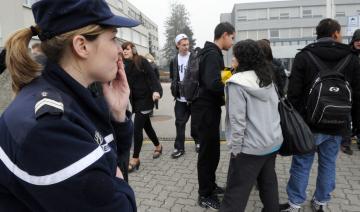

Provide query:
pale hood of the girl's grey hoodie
left=226, top=70, right=273, bottom=101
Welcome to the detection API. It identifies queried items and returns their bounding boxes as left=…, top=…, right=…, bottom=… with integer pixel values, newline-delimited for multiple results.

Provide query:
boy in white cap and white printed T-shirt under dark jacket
left=170, top=34, right=200, bottom=159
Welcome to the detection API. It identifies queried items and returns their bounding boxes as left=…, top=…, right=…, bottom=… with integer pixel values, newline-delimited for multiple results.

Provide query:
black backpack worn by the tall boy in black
left=179, top=49, right=201, bottom=102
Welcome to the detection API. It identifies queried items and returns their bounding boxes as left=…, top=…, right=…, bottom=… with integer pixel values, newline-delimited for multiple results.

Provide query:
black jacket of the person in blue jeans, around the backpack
left=288, top=40, right=360, bottom=135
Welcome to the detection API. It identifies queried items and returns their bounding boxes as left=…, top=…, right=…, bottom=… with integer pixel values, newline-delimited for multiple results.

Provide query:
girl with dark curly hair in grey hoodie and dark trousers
left=220, top=40, right=283, bottom=212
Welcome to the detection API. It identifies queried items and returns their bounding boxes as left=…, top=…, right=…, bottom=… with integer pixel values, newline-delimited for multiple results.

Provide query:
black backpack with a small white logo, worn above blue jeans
left=306, top=51, right=352, bottom=130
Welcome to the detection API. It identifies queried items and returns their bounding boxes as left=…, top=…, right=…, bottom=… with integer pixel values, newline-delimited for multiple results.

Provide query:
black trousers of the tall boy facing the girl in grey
left=191, top=103, right=221, bottom=197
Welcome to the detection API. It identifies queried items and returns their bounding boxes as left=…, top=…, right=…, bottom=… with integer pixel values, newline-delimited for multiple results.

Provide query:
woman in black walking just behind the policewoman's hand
left=121, top=42, right=163, bottom=173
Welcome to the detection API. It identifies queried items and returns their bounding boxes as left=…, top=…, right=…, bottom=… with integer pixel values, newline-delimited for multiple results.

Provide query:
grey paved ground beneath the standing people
left=129, top=142, right=360, bottom=212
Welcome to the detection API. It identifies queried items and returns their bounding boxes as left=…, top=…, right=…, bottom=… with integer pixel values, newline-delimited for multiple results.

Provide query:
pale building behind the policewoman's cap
left=0, top=0, right=159, bottom=56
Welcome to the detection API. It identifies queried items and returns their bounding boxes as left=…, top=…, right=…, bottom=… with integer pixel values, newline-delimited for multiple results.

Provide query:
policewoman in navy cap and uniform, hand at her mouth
left=0, top=0, right=139, bottom=212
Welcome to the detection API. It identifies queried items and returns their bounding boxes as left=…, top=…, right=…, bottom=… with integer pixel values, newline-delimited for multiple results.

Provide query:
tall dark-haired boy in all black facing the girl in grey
left=191, top=22, right=235, bottom=210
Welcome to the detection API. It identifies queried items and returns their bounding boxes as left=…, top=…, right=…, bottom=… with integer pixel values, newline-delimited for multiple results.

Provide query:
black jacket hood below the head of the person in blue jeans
left=302, top=39, right=351, bottom=62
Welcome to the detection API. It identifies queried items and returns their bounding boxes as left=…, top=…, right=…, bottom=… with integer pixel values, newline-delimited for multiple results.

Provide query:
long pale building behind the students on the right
left=220, top=0, right=360, bottom=68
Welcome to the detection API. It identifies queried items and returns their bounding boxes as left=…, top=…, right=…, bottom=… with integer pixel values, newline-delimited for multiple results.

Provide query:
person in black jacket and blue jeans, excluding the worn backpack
left=280, top=19, right=360, bottom=211
